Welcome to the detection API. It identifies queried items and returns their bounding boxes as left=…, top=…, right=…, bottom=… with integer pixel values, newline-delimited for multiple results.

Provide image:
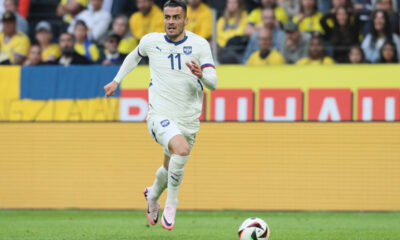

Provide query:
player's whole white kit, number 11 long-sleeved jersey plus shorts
left=114, top=31, right=217, bottom=154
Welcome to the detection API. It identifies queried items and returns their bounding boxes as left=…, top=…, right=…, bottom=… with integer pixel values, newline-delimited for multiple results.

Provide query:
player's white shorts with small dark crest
left=147, top=114, right=196, bottom=156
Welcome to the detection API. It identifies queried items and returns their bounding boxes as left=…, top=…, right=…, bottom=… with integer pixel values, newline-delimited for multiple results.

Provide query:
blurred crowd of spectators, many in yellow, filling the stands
left=0, top=0, right=400, bottom=66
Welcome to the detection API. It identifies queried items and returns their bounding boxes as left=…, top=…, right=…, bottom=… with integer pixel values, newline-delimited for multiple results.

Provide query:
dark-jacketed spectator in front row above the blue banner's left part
left=52, top=32, right=90, bottom=66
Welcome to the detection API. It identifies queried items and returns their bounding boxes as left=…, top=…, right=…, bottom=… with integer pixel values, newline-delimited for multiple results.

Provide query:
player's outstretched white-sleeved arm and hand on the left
left=104, top=46, right=142, bottom=97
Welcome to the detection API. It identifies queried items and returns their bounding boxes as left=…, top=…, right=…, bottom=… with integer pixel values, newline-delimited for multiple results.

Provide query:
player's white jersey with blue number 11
left=138, top=31, right=214, bottom=129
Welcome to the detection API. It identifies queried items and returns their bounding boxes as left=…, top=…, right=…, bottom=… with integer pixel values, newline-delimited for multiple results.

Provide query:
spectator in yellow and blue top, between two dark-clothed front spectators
left=74, top=20, right=100, bottom=63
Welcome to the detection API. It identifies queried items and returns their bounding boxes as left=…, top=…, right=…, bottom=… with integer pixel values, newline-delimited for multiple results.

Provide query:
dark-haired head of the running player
left=163, top=0, right=188, bottom=40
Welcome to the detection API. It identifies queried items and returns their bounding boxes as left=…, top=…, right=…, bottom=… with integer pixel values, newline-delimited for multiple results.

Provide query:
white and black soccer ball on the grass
left=238, top=218, right=270, bottom=240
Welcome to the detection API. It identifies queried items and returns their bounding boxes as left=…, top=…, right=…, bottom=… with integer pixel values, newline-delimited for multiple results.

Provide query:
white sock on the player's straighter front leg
left=166, top=154, right=189, bottom=206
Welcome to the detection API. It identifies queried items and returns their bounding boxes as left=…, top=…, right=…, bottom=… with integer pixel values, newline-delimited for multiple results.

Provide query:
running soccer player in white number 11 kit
left=104, top=0, right=217, bottom=230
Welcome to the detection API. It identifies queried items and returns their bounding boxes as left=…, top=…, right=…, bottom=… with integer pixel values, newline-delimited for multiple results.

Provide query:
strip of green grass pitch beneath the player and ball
left=0, top=210, right=400, bottom=240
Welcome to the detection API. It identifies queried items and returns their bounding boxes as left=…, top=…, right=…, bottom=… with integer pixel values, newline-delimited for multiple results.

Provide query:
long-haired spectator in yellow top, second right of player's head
left=217, top=0, right=247, bottom=47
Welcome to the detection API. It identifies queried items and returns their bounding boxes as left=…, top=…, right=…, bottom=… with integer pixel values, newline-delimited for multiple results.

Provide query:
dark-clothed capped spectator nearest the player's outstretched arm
left=100, top=33, right=126, bottom=65
